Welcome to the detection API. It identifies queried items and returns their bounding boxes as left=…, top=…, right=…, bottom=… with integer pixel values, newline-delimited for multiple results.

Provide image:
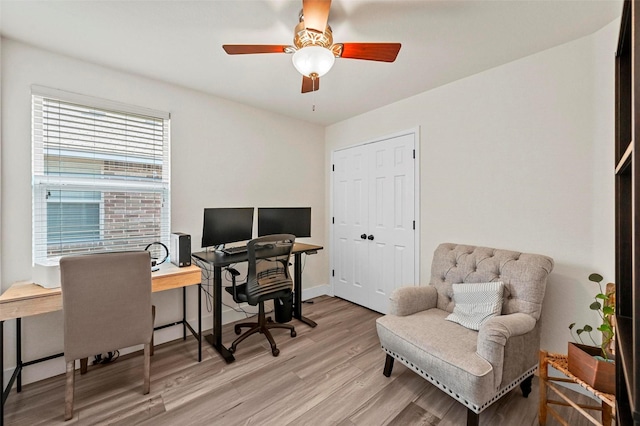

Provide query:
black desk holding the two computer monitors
left=192, top=243, right=322, bottom=363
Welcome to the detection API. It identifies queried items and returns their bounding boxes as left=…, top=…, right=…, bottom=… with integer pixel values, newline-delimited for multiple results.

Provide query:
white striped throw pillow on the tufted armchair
left=446, top=281, right=504, bottom=330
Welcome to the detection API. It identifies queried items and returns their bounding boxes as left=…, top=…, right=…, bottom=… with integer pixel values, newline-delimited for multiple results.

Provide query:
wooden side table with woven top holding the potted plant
left=538, top=350, right=616, bottom=426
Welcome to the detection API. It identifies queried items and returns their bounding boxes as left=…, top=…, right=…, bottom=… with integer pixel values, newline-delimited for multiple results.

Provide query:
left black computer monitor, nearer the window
left=202, top=207, right=253, bottom=247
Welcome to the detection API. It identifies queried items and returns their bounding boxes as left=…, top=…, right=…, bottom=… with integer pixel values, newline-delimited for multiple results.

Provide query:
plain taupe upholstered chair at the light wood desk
left=60, top=251, right=153, bottom=420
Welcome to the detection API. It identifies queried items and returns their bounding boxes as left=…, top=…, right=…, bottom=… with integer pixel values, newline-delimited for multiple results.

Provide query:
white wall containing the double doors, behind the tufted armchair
left=325, top=18, right=619, bottom=352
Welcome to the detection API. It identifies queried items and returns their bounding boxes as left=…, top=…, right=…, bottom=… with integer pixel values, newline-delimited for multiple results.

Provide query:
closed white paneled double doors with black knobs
left=333, top=133, right=416, bottom=313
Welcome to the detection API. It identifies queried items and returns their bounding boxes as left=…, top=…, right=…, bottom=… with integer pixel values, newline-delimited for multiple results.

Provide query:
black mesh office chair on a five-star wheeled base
left=225, top=234, right=296, bottom=356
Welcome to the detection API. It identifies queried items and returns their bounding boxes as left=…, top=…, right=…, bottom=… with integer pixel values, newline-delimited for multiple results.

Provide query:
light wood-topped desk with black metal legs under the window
left=0, top=263, right=202, bottom=425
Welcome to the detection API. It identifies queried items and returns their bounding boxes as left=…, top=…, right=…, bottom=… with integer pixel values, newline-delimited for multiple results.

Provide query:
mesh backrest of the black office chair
left=247, top=234, right=296, bottom=305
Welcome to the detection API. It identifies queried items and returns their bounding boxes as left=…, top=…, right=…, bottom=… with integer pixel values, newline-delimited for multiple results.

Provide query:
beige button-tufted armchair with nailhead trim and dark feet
left=376, top=244, right=553, bottom=425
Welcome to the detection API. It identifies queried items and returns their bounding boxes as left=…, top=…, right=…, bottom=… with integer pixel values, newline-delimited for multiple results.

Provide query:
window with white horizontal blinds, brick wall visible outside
left=32, top=86, right=170, bottom=263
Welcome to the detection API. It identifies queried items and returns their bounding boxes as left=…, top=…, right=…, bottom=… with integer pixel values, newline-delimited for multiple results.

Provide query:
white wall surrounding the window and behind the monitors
left=0, top=39, right=328, bottom=382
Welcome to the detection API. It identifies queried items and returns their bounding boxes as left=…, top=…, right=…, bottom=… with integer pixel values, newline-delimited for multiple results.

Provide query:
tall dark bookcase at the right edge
left=614, top=0, right=640, bottom=426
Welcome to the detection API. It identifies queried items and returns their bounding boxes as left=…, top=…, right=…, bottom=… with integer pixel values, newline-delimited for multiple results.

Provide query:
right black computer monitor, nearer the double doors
left=258, top=207, right=311, bottom=238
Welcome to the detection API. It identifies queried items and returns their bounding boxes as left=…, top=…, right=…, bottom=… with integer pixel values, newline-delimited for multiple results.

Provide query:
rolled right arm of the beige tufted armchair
left=476, top=312, right=539, bottom=387
